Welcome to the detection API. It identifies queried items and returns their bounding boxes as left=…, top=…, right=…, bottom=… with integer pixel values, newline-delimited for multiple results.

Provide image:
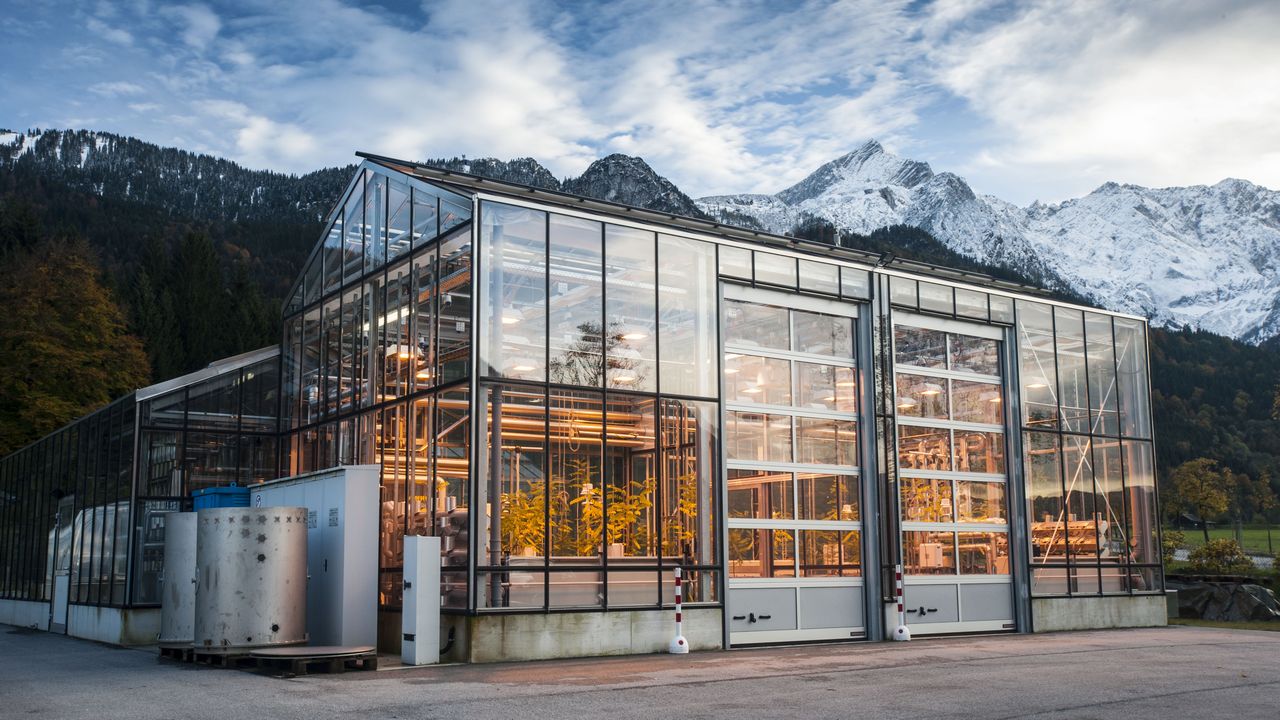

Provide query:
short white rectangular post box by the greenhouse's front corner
left=401, top=536, right=440, bottom=665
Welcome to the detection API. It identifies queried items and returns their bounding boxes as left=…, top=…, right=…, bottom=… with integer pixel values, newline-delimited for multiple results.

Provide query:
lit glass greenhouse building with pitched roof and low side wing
left=0, top=155, right=1165, bottom=661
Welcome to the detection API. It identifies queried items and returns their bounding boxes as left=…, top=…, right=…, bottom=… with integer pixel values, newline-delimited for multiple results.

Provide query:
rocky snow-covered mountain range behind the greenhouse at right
left=698, top=141, right=1280, bottom=343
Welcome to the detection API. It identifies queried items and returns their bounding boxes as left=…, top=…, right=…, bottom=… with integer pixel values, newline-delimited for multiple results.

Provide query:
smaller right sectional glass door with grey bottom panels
left=893, top=314, right=1015, bottom=635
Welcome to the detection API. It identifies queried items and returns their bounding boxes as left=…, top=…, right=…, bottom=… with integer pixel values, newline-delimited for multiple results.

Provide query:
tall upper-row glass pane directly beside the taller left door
left=658, top=234, right=719, bottom=397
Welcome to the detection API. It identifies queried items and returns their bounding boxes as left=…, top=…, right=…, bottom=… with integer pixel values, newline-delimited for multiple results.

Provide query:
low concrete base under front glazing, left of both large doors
left=467, top=607, right=723, bottom=662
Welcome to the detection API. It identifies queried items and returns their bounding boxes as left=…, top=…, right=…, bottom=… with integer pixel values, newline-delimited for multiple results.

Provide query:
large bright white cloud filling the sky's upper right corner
left=936, top=0, right=1280, bottom=200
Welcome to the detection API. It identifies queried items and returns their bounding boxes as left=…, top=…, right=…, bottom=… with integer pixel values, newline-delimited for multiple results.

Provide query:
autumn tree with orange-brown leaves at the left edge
left=0, top=234, right=148, bottom=455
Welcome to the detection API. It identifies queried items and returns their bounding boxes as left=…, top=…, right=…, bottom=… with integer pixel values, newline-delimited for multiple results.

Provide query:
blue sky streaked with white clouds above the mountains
left=0, top=0, right=1280, bottom=204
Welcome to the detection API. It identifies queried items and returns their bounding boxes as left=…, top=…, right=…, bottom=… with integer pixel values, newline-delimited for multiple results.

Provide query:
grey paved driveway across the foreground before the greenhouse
left=0, top=625, right=1280, bottom=720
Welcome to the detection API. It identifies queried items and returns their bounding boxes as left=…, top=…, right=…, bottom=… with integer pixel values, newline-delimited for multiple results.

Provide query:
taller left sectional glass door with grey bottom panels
left=722, top=286, right=865, bottom=644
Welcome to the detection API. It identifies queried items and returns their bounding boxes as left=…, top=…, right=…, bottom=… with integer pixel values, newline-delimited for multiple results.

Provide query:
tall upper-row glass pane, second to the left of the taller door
left=604, top=225, right=658, bottom=391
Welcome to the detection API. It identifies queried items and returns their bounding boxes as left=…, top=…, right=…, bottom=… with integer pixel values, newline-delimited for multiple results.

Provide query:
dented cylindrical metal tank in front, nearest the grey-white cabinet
left=195, top=507, right=307, bottom=652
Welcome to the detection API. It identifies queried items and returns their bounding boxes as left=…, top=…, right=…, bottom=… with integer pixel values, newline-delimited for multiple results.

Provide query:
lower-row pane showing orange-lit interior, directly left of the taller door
left=658, top=400, right=719, bottom=565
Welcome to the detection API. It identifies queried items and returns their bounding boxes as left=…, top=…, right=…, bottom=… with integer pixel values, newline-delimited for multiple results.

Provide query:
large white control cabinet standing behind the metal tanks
left=250, top=465, right=379, bottom=647
